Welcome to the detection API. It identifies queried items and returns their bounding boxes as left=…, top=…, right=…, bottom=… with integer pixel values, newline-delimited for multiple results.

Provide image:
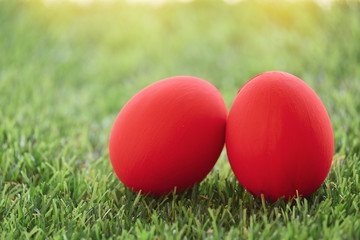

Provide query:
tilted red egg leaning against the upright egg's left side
left=109, top=76, right=227, bottom=195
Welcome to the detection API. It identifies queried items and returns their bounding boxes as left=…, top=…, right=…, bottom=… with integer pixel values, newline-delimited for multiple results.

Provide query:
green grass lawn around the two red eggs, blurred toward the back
left=0, top=0, right=360, bottom=239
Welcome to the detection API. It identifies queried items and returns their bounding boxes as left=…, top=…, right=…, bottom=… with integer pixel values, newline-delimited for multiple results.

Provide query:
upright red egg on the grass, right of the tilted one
left=226, top=72, right=334, bottom=201
